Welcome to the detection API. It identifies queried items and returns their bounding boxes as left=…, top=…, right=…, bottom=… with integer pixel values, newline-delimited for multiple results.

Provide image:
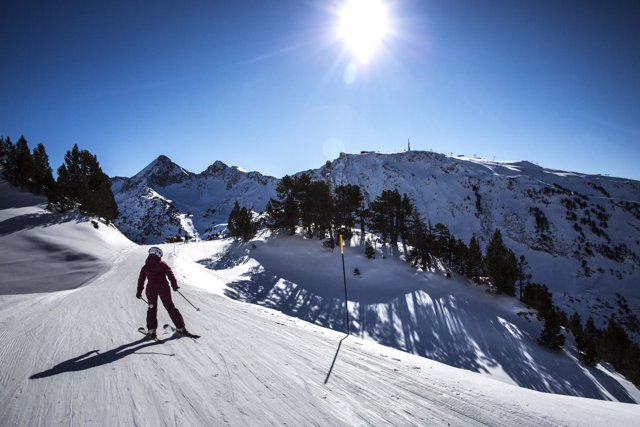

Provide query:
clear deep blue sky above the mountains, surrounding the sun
left=0, top=0, right=640, bottom=179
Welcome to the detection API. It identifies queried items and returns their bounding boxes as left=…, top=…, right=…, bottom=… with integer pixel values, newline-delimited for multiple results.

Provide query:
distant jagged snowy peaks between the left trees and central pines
left=112, top=156, right=277, bottom=243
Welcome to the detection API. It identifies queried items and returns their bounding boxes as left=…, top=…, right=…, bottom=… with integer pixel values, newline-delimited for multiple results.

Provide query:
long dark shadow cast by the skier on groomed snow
left=29, top=337, right=175, bottom=380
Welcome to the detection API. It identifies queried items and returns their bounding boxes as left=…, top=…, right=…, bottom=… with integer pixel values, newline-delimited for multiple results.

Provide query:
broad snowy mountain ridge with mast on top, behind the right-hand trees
left=307, top=151, right=640, bottom=332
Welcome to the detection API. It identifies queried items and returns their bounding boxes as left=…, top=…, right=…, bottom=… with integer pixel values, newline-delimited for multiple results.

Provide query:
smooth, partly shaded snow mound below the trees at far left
left=0, top=180, right=132, bottom=295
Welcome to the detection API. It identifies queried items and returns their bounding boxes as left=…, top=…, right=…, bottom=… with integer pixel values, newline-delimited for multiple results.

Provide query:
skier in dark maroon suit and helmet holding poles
left=136, top=246, right=189, bottom=338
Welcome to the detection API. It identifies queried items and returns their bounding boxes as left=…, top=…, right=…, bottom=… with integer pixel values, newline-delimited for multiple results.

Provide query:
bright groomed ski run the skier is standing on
left=0, top=182, right=640, bottom=426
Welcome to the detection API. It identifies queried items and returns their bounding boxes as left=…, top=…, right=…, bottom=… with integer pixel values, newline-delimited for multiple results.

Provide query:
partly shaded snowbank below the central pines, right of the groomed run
left=180, top=236, right=640, bottom=402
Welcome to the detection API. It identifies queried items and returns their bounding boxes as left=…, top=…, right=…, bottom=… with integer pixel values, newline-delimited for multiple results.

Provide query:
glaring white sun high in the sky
left=338, top=0, right=389, bottom=63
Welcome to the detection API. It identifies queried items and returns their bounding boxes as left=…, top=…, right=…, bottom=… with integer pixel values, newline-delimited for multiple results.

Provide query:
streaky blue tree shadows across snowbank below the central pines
left=219, top=254, right=635, bottom=403
